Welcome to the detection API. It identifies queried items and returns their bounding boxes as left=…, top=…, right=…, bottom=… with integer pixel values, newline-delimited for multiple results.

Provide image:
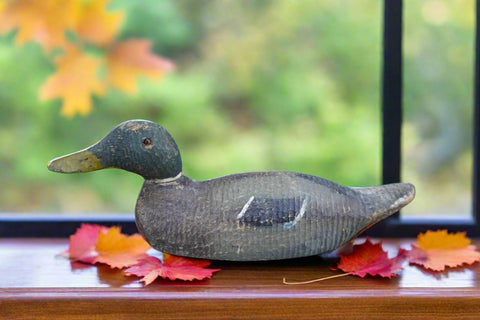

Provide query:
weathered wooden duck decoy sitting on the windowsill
left=48, top=120, right=415, bottom=261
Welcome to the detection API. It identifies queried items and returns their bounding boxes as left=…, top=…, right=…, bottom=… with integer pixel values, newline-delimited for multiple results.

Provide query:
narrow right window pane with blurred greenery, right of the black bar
left=402, top=0, right=475, bottom=218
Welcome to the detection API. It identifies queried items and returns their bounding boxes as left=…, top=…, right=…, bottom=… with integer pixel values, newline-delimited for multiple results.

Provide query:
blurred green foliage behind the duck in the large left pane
left=0, top=0, right=471, bottom=213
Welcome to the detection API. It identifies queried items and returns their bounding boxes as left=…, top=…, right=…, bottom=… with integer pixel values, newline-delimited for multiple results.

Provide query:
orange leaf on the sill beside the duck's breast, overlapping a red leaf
left=94, top=227, right=150, bottom=269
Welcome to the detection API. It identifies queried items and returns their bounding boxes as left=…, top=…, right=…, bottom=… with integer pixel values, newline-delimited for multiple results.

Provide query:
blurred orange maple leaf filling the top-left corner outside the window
left=0, top=0, right=81, bottom=51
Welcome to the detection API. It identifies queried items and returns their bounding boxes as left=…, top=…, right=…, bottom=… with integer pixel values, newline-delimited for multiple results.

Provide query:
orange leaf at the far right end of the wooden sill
left=408, top=230, right=480, bottom=271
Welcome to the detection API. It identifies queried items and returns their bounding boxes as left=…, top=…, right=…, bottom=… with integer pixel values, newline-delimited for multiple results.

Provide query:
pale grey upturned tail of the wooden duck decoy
left=354, top=183, right=415, bottom=223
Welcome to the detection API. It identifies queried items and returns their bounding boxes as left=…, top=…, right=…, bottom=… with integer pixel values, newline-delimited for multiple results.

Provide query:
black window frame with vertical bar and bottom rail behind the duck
left=0, top=0, right=480, bottom=237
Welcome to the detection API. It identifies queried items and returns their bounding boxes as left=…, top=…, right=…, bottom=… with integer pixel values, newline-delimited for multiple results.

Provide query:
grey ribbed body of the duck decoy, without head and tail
left=136, top=171, right=412, bottom=260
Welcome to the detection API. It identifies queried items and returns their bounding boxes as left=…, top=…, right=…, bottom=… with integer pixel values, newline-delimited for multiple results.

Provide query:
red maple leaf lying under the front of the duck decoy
left=125, top=253, right=220, bottom=285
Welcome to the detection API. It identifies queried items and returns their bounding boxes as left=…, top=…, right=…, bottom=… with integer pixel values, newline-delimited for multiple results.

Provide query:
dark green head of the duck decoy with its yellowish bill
left=48, top=120, right=182, bottom=179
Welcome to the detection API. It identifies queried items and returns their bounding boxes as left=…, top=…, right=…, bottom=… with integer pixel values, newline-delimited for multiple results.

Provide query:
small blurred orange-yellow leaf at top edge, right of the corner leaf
left=76, top=0, right=124, bottom=46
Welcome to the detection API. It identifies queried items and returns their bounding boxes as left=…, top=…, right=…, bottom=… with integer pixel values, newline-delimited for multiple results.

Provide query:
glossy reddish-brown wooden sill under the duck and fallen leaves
left=0, top=239, right=480, bottom=320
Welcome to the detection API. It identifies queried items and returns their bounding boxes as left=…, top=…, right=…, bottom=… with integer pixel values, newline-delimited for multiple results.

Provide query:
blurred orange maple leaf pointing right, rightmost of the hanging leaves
left=107, top=39, right=174, bottom=93
